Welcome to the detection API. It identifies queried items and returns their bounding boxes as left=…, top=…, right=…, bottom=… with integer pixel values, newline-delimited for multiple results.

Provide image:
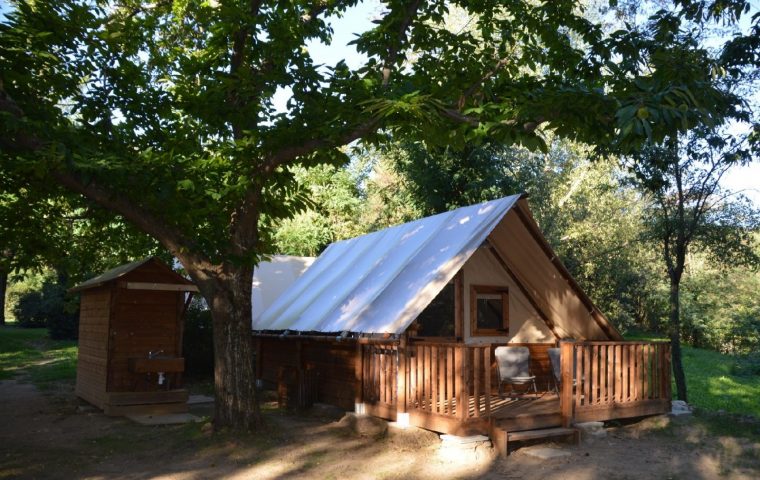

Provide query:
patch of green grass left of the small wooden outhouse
left=0, top=326, right=77, bottom=389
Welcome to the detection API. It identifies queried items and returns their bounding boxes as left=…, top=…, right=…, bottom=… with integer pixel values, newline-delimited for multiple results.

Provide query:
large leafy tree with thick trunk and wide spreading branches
left=0, top=0, right=752, bottom=429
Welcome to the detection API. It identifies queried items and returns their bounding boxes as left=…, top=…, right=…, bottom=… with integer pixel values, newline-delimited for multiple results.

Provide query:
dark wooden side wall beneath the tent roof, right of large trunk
left=254, top=337, right=357, bottom=410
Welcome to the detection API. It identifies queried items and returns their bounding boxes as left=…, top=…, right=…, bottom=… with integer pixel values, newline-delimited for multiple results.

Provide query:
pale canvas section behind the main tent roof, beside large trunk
left=251, top=255, right=315, bottom=323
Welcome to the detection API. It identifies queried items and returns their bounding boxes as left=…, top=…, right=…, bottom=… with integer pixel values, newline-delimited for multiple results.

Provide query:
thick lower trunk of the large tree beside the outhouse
left=204, top=265, right=261, bottom=430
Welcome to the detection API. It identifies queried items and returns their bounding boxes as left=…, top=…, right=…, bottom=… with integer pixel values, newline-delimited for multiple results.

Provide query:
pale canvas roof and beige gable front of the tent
left=253, top=195, right=621, bottom=343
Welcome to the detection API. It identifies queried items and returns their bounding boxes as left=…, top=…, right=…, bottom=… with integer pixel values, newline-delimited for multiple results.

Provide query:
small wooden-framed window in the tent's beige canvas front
left=470, top=285, right=509, bottom=335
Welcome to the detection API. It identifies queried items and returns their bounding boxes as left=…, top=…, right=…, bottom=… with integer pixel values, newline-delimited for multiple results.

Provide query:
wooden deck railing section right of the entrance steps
left=560, top=341, right=671, bottom=425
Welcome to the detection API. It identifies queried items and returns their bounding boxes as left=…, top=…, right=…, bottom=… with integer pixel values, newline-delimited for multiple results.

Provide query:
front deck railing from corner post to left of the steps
left=400, top=342, right=494, bottom=420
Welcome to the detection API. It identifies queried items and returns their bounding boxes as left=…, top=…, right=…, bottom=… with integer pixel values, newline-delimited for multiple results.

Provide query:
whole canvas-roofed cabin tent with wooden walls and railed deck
left=253, top=195, right=670, bottom=446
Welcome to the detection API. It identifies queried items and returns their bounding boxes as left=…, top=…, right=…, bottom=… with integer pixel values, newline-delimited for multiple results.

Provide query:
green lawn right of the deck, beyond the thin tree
left=626, top=333, right=760, bottom=418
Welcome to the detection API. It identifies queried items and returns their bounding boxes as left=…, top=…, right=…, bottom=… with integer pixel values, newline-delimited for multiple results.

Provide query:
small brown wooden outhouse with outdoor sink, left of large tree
left=70, top=257, right=198, bottom=415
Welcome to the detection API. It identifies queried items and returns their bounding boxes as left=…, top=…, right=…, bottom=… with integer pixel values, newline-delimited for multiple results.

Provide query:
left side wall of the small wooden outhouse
left=76, top=286, right=111, bottom=408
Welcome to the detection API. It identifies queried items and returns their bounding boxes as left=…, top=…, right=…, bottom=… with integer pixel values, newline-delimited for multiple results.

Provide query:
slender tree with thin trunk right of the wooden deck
left=629, top=129, right=760, bottom=401
